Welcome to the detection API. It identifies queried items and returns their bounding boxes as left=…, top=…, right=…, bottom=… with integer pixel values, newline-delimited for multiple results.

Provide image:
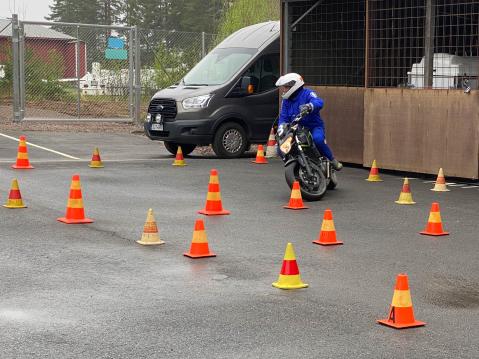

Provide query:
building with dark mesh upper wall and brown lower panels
left=281, top=0, right=479, bottom=179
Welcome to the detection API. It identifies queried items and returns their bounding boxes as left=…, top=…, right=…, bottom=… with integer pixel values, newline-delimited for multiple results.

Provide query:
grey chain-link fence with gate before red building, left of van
left=0, top=16, right=216, bottom=121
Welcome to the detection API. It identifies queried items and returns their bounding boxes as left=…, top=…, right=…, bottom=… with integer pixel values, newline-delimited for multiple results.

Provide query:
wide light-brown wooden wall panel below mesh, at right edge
left=364, top=89, right=479, bottom=179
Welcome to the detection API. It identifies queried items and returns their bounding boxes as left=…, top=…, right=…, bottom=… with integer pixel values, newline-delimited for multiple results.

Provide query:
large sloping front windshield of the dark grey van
left=183, top=47, right=257, bottom=86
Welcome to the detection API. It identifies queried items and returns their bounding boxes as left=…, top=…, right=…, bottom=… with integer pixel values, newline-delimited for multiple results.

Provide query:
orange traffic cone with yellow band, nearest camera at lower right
left=377, top=273, right=426, bottom=329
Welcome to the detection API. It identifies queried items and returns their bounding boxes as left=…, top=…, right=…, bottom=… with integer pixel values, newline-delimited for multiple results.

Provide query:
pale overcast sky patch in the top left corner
left=0, top=0, right=53, bottom=21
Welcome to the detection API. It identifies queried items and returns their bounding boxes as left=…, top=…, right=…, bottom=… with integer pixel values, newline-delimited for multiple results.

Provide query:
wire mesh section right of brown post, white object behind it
left=369, top=0, right=479, bottom=89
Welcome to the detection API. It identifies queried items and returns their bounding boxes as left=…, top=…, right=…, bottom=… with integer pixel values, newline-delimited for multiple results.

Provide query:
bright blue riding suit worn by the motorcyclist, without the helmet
left=278, top=87, right=334, bottom=161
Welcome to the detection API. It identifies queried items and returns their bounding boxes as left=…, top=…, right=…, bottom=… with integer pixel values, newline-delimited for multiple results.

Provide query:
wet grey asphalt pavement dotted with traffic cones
left=0, top=132, right=479, bottom=358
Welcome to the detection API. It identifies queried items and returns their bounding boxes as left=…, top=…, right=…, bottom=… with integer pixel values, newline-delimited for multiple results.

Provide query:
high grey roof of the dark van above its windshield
left=217, top=21, right=280, bottom=49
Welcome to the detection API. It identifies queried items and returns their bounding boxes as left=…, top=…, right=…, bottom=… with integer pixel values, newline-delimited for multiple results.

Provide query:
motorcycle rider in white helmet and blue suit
left=276, top=72, right=343, bottom=171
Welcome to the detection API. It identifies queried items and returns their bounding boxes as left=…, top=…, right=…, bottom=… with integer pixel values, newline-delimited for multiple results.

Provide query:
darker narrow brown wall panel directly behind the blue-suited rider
left=306, top=85, right=365, bottom=164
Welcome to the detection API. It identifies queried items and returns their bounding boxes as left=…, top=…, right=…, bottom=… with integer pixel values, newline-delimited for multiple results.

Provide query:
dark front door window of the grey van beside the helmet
left=243, top=54, right=279, bottom=93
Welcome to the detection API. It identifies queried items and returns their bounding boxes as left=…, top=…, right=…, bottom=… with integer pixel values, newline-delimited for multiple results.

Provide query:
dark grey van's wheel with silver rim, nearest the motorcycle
left=213, top=122, right=248, bottom=158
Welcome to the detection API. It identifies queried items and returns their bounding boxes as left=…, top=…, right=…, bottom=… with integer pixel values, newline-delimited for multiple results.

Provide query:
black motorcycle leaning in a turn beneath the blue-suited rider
left=276, top=112, right=338, bottom=201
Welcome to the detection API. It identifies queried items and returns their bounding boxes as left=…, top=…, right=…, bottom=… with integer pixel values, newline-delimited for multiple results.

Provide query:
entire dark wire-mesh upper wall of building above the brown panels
left=283, top=0, right=479, bottom=92
